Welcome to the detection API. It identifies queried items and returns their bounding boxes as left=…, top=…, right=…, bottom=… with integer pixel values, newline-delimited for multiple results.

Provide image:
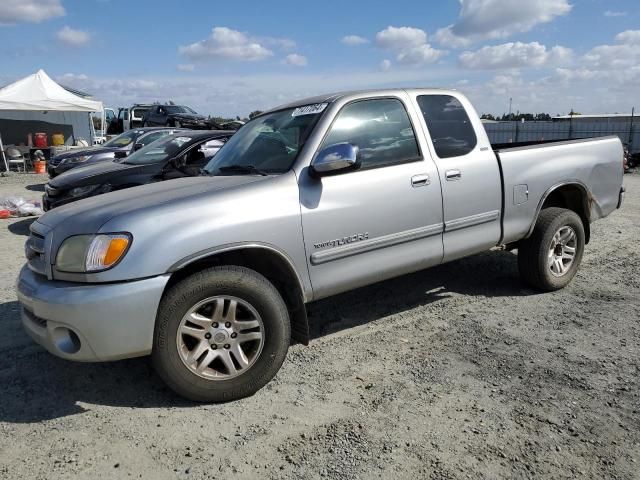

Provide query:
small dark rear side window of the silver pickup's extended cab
left=418, top=95, right=478, bottom=158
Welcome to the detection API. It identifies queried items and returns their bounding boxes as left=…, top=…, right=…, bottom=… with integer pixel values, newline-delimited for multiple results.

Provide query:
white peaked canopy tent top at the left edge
left=0, top=70, right=104, bottom=170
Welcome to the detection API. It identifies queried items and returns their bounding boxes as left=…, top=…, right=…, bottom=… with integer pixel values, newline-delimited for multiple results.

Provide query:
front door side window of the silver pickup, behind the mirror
left=321, top=98, right=421, bottom=169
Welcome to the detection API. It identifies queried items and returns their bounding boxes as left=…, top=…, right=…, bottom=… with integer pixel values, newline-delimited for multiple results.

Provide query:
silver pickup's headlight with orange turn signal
left=56, top=233, right=133, bottom=273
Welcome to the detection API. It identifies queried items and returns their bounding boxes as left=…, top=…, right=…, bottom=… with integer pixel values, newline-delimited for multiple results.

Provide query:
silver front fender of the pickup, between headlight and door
left=91, top=172, right=311, bottom=294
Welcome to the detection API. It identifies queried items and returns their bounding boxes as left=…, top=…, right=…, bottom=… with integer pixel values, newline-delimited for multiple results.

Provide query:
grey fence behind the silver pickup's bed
left=484, top=118, right=640, bottom=153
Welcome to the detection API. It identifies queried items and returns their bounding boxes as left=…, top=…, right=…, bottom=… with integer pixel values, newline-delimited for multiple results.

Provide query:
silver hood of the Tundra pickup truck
left=37, top=175, right=270, bottom=237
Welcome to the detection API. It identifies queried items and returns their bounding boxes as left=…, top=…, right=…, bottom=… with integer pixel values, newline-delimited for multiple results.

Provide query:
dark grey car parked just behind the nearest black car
left=47, top=127, right=184, bottom=178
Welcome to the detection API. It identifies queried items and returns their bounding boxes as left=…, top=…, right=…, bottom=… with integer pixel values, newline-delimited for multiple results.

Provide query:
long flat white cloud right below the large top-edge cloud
left=459, top=42, right=573, bottom=70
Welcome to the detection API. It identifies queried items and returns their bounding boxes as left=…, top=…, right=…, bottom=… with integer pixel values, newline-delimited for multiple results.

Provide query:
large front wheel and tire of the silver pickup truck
left=151, top=266, right=291, bottom=402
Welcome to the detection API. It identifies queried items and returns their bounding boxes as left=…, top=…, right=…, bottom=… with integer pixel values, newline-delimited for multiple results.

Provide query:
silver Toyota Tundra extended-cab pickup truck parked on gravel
left=17, top=89, right=624, bottom=401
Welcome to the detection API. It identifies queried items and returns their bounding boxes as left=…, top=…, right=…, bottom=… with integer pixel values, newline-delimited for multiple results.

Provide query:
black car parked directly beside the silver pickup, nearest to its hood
left=42, top=131, right=233, bottom=211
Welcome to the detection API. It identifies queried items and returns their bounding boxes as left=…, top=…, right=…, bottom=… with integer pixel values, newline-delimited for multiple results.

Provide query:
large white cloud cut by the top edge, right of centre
left=434, top=0, right=572, bottom=48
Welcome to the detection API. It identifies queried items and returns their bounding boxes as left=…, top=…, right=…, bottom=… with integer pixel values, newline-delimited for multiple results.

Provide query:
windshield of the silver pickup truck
left=204, top=104, right=326, bottom=175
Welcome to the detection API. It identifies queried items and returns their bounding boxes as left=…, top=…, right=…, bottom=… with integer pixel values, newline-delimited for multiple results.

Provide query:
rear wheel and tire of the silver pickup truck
left=518, top=207, right=584, bottom=292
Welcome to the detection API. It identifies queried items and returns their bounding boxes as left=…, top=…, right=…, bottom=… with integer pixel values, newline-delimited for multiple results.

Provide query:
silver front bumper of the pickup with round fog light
left=16, top=266, right=169, bottom=362
